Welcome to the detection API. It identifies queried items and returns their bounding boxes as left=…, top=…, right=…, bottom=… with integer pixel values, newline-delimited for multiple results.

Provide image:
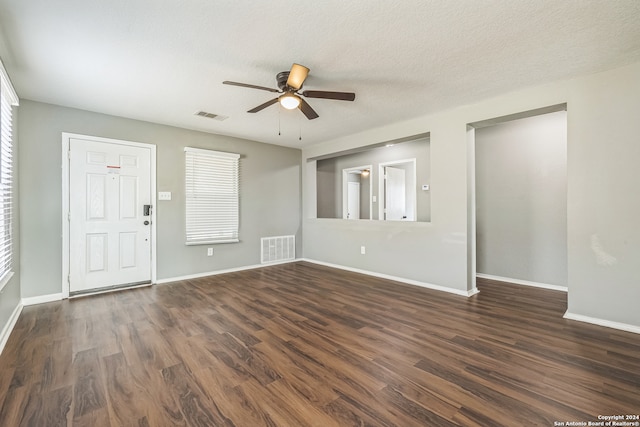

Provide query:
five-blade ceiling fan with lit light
left=222, top=64, right=356, bottom=120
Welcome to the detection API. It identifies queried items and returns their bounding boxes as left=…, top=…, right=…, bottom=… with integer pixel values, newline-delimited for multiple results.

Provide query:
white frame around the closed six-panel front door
left=61, top=132, right=158, bottom=298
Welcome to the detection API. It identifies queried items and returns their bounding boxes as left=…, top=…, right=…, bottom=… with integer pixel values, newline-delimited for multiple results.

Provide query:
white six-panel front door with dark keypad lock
left=69, top=138, right=151, bottom=293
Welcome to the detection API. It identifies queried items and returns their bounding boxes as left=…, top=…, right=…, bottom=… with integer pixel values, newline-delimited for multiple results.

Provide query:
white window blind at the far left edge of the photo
left=0, top=58, right=18, bottom=289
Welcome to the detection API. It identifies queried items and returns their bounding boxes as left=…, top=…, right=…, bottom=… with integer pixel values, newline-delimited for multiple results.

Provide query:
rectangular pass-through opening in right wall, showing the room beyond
left=314, top=134, right=431, bottom=222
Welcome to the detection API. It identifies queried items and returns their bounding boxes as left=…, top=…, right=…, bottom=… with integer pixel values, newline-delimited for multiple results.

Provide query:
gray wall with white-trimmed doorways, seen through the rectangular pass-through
left=316, top=138, right=431, bottom=222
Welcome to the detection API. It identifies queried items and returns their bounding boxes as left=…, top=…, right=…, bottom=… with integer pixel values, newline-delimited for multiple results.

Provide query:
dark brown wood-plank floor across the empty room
left=0, top=262, right=640, bottom=427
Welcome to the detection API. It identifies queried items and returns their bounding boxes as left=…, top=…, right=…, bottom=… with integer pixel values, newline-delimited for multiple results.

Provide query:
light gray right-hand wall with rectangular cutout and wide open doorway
left=302, top=62, right=640, bottom=328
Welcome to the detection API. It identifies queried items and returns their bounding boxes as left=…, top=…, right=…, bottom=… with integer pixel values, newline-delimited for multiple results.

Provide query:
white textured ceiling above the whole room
left=0, top=0, right=640, bottom=147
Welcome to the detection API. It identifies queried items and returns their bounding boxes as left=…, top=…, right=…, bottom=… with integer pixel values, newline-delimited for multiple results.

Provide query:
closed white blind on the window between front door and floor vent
left=184, top=147, right=240, bottom=245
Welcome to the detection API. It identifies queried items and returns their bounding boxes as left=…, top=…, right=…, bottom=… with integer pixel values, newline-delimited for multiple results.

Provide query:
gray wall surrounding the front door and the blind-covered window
left=18, top=100, right=301, bottom=297
